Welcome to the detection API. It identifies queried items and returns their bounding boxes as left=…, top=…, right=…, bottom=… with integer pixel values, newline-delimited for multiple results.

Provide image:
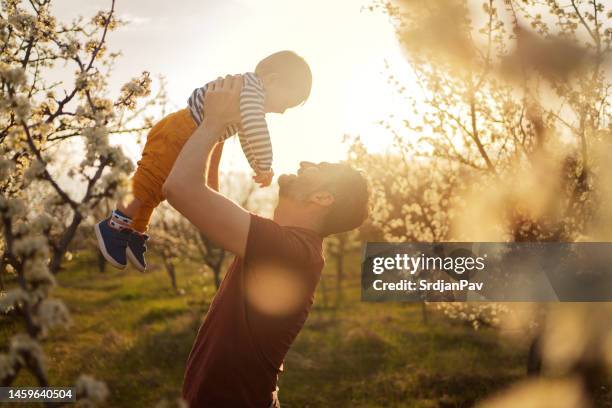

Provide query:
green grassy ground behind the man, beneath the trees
left=0, top=253, right=526, bottom=407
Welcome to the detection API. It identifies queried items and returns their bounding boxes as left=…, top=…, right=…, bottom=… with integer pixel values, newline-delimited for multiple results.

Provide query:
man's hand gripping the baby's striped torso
left=202, top=75, right=242, bottom=130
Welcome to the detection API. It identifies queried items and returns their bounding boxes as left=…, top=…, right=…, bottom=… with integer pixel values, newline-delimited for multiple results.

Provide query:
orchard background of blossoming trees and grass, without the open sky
left=0, top=0, right=612, bottom=408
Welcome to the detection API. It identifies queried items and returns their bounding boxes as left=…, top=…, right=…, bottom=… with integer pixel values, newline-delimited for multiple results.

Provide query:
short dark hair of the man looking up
left=321, top=163, right=369, bottom=236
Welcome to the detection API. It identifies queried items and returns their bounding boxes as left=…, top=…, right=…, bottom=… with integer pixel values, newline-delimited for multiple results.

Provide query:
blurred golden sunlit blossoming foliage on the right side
left=350, top=0, right=612, bottom=407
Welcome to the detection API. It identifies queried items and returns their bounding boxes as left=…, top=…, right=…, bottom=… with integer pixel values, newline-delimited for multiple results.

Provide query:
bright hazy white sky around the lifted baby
left=54, top=0, right=408, bottom=175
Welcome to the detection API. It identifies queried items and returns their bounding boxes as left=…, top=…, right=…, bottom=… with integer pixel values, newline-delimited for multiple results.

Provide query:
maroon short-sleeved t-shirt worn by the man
left=183, top=215, right=324, bottom=408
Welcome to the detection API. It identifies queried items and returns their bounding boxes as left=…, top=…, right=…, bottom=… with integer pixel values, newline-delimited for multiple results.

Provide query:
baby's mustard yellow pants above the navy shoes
left=132, top=109, right=196, bottom=232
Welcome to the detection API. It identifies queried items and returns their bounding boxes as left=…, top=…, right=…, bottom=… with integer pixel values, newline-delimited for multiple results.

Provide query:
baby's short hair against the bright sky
left=255, top=51, right=312, bottom=103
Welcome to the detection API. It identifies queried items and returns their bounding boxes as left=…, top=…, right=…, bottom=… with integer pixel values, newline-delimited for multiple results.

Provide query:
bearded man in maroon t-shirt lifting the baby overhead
left=164, top=76, right=368, bottom=408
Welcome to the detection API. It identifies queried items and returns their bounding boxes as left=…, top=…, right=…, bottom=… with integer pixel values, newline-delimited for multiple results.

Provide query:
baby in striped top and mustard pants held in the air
left=95, top=51, right=312, bottom=271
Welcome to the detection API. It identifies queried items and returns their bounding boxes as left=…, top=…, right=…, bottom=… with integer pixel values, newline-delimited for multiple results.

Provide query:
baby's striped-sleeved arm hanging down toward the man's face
left=238, top=74, right=273, bottom=187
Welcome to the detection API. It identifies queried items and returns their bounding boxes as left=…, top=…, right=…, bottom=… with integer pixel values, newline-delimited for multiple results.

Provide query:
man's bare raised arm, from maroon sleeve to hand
left=163, top=77, right=250, bottom=256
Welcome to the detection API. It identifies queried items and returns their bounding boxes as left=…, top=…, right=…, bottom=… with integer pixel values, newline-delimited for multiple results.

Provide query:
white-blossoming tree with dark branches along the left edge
left=0, top=0, right=163, bottom=403
